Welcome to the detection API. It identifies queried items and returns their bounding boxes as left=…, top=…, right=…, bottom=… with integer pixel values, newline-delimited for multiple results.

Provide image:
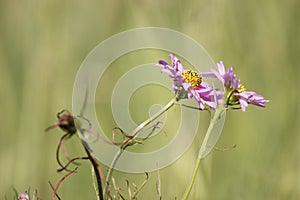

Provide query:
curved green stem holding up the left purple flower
left=105, top=96, right=177, bottom=195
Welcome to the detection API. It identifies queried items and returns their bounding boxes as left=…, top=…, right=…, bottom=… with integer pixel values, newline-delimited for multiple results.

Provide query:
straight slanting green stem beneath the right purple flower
left=183, top=101, right=226, bottom=200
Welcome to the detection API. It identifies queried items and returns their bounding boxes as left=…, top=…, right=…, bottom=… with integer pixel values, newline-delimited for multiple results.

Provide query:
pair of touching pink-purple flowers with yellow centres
left=158, top=54, right=269, bottom=111
